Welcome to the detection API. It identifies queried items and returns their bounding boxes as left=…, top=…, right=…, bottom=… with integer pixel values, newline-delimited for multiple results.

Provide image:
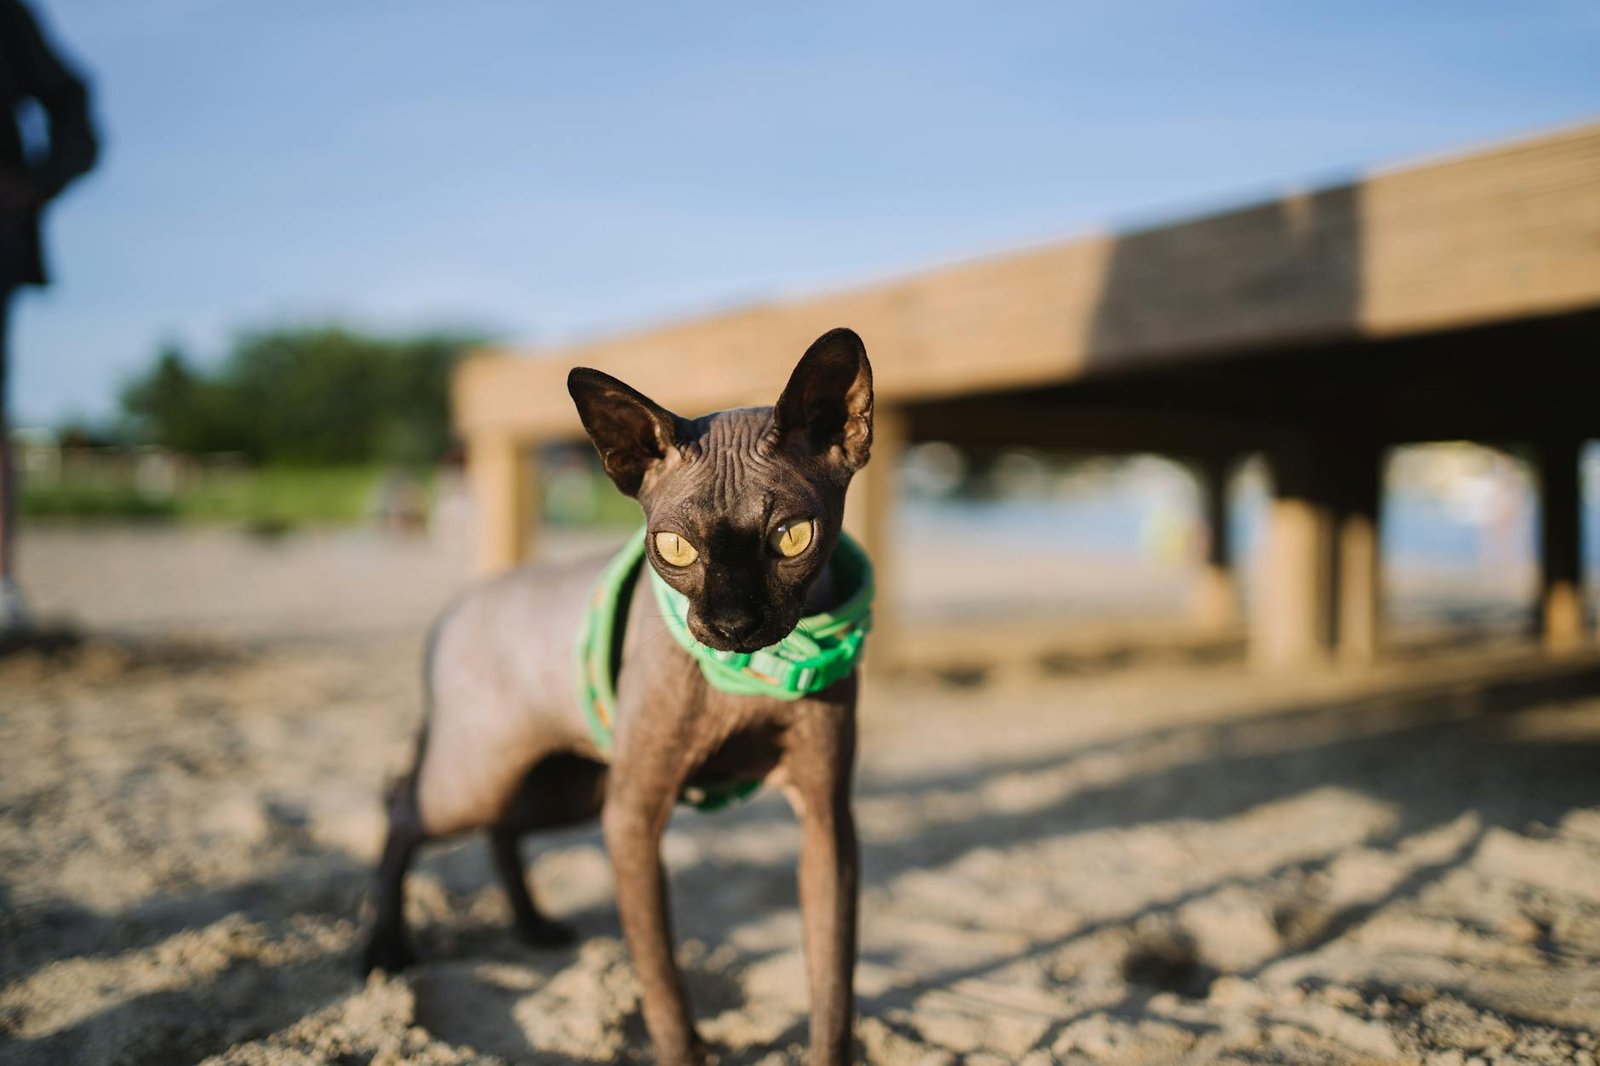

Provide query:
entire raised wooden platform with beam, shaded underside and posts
left=453, top=125, right=1600, bottom=667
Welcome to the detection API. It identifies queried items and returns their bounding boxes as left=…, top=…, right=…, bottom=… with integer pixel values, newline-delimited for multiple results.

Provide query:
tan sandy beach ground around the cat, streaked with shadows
left=0, top=530, right=1600, bottom=1066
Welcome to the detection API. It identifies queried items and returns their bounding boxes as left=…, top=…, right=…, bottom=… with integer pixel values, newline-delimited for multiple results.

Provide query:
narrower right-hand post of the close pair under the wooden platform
left=1330, top=447, right=1382, bottom=664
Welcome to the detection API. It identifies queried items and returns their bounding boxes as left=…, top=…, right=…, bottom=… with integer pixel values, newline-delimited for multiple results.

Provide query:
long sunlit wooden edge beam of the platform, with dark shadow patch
left=454, top=125, right=1600, bottom=440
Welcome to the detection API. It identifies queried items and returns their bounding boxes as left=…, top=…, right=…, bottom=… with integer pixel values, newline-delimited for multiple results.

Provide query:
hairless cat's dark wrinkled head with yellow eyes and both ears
left=566, top=330, right=872, bottom=651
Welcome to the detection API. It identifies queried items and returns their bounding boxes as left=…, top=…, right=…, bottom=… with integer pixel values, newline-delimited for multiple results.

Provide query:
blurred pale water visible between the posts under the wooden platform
left=901, top=443, right=1600, bottom=624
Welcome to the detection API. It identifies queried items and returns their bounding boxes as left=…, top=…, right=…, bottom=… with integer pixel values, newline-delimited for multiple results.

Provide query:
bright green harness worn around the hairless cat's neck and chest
left=573, top=530, right=874, bottom=810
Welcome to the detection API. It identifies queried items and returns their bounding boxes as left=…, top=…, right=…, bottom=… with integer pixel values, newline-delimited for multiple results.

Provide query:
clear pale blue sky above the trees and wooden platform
left=13, top=0, right=1600, bottom=424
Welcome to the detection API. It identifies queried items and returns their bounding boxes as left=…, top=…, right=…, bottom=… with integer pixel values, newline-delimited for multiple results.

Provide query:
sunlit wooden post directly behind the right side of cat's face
left=845, top=407, right=907, bottom=669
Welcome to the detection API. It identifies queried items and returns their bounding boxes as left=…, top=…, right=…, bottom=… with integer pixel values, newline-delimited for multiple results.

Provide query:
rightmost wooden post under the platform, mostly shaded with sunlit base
left=1538, top=437, right=1584, bottom=653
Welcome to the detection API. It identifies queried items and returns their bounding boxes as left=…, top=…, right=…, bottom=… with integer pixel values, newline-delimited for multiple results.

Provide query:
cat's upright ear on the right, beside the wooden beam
left=773, top=330, right=872, bottom=477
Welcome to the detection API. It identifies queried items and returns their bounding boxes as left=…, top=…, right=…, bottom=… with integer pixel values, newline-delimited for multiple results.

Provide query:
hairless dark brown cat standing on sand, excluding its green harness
left=363, top=330, right=872, bottom=1063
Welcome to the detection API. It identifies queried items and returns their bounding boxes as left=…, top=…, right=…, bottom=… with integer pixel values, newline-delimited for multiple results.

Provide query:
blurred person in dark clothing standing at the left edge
left=0, top=0, right=98, bottom=632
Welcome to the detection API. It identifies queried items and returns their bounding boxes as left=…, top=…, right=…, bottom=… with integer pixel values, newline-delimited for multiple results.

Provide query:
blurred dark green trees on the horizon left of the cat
left=122, top=327, right=478, bottom=466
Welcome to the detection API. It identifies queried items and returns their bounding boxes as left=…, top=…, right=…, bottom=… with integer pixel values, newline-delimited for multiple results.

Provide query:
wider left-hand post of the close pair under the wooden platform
left=1250, top=445, right=1334, bottom=669
